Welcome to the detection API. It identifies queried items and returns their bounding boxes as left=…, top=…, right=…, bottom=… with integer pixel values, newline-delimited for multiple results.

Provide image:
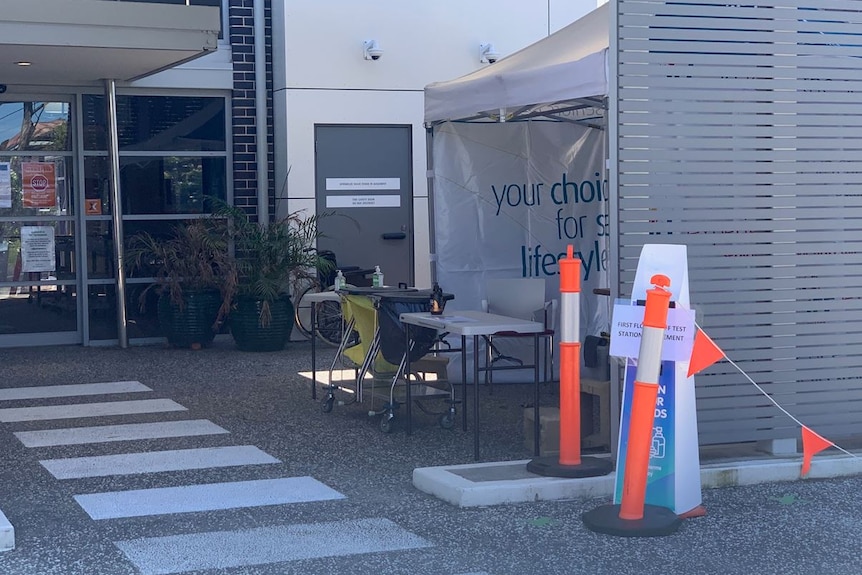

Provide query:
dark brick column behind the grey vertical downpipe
left=228, top=0, right=275, bottom=220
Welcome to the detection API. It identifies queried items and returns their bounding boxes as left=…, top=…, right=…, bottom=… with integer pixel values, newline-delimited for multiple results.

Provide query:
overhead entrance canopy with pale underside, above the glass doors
left=0, top=0, right=221, bottom=86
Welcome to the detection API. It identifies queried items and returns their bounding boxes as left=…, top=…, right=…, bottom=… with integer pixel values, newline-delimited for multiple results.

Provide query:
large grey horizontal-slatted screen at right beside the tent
left=612, top=0, right=862, bottom=444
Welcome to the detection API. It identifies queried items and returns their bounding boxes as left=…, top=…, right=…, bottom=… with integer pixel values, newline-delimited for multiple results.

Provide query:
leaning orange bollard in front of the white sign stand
left=582, top=275, right=680, bottom=537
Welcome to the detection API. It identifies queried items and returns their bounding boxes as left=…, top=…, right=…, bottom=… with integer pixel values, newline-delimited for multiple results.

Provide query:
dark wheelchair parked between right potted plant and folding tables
left=293, top=250, right=374, bottom=347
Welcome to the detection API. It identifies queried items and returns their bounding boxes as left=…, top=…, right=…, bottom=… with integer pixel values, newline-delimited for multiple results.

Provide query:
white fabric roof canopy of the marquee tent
left=425, top=3, right=609, bottom=124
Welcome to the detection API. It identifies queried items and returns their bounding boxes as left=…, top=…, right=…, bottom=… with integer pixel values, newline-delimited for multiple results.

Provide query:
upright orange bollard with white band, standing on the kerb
left=527, top=245, right=613, bottom=477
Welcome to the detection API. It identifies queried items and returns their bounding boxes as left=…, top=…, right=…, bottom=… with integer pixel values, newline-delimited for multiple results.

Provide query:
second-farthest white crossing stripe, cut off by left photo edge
left=0, top=399, right=186, bottom=423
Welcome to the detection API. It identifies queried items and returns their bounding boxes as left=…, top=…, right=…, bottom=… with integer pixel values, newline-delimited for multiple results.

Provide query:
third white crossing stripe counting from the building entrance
left=14, top=419, right=228, bottom=447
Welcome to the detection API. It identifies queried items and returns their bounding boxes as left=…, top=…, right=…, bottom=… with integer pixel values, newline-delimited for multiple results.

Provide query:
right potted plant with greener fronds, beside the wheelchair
left=221, top=206, right=332, bottom=351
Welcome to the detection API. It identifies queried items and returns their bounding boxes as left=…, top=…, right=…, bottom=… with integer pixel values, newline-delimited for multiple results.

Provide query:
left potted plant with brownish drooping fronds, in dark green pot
left=126, top=217, right=237, bottom=349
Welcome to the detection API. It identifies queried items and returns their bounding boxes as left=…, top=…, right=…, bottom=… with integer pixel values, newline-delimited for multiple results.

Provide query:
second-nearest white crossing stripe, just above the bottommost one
left=75, top=477, right=344, bottom=519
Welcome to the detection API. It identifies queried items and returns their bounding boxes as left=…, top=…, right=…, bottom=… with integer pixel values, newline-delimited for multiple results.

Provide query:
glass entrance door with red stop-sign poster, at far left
left=0, top=101, right=81, bottom=347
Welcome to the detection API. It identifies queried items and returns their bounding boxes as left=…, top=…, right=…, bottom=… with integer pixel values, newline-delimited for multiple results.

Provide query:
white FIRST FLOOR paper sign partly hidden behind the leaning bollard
left=609, top=304, right=695, bottom=362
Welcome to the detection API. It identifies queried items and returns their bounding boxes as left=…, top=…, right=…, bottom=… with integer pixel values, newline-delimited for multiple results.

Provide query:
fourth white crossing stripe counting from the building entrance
left=39, top=445, right=281, bottom=479
